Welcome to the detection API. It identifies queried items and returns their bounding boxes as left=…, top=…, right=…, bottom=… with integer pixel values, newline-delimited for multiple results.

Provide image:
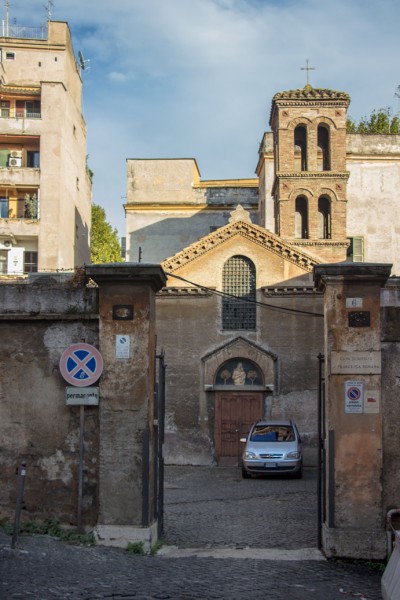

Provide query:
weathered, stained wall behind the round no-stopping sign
left=0, top=276, right=99, bottom=525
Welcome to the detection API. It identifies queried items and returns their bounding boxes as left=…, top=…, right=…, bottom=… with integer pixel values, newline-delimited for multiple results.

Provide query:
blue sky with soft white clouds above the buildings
left=5, top=0, right=400, bottom=236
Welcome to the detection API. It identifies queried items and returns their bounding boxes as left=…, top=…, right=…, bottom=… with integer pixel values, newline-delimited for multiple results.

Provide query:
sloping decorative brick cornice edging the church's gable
left=161, top=219, right=320, bottom=273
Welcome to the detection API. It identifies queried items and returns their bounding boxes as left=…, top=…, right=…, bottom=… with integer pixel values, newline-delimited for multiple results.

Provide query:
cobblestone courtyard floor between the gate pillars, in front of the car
left=164, top=467, right=318, bottom=549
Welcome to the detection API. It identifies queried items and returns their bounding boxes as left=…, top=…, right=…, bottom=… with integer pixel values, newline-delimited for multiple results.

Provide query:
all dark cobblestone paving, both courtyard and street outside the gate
left=0, top=467, right=381, bottom=600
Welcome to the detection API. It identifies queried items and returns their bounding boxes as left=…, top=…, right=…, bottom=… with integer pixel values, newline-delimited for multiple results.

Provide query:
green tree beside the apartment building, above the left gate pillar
left=90, top=204, right=122, bottom=263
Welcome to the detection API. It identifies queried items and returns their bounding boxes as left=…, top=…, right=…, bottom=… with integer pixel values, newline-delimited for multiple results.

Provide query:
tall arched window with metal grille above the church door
left=222, top=256, right=256, bottom=329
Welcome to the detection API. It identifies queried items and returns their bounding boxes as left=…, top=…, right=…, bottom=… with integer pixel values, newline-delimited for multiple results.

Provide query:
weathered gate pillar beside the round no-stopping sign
left=86, top=263, right=166, bottom=550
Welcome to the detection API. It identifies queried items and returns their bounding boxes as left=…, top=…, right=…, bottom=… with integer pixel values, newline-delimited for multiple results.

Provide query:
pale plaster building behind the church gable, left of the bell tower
left=125, top=159, right=258, bottom=262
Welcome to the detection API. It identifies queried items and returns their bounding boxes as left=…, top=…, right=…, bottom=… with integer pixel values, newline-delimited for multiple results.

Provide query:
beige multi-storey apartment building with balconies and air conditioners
left=0, top=21, right=91, bottom=276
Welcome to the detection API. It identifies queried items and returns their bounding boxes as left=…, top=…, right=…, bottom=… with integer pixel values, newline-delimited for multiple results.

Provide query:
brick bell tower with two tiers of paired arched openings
left=270, top=84, right=350, bottom=262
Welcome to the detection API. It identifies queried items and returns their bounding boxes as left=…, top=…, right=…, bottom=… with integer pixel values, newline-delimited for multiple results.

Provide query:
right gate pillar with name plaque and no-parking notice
left=314, top=263, right=391, bottom=559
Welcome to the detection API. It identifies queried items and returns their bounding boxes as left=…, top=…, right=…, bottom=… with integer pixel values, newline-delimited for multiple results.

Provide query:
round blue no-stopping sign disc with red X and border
left=60, top=344, right=103, bottom=387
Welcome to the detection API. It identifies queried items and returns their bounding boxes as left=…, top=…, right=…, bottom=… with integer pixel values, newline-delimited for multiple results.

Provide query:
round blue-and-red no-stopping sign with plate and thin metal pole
left=60, top=343, right=103, bottom=531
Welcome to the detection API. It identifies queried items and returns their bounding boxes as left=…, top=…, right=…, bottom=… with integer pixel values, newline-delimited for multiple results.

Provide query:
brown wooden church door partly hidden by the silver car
left=214, top=391, right=264, bottom=466
